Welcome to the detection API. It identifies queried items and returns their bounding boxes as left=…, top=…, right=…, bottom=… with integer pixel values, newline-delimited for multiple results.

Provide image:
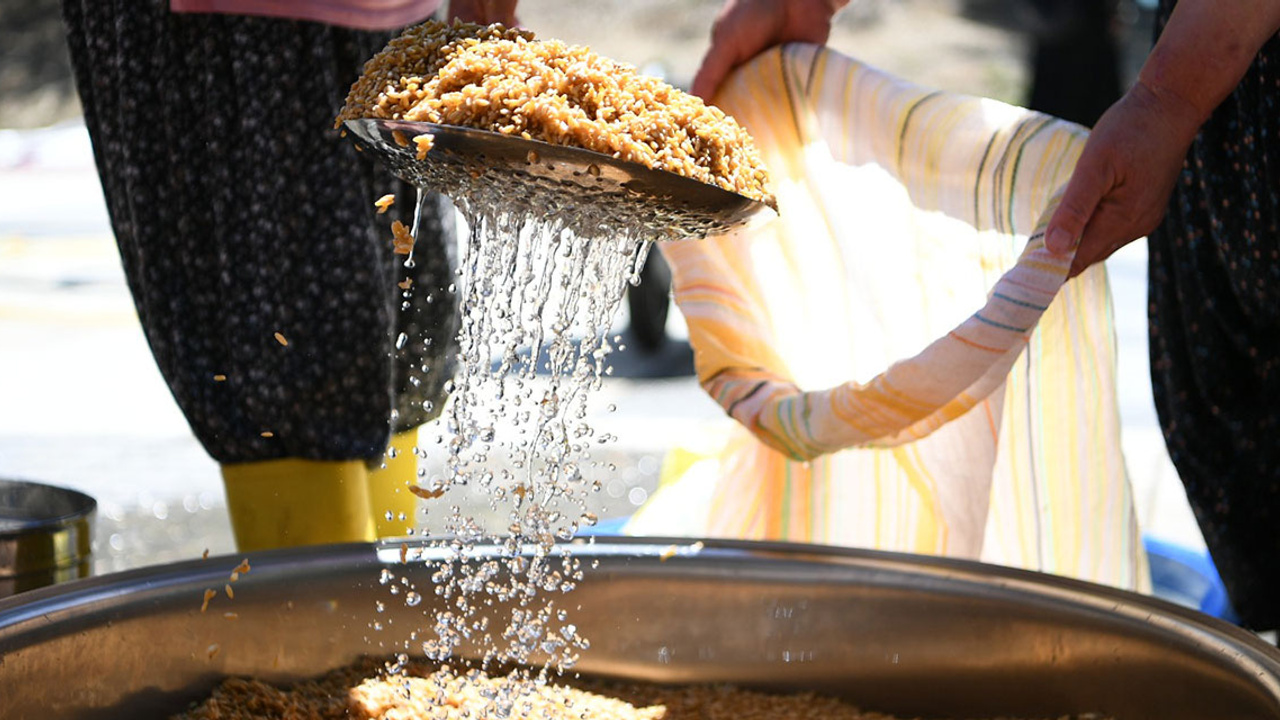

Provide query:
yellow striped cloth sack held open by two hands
left=627, top=45, right=1149, bottom=589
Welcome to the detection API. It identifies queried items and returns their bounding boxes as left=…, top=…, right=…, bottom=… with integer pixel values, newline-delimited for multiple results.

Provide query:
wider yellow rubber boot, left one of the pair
left=223, top=457, right=375, bottom=552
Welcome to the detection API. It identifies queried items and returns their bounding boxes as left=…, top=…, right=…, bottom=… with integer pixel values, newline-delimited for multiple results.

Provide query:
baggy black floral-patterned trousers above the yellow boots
left=64, top=0, right=457, bottom=464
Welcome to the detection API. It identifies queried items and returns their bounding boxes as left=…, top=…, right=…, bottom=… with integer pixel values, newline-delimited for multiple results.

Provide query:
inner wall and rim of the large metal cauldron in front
left=0, top=539, right=1280, bottom=720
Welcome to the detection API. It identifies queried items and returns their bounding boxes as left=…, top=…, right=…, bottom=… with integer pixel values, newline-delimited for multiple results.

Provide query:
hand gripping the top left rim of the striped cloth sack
left=692, top=0, right=849, bottom=100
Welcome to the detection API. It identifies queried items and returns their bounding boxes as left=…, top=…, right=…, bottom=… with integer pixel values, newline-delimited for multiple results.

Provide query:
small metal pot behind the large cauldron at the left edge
left=0, top=479, right=97, bottom=598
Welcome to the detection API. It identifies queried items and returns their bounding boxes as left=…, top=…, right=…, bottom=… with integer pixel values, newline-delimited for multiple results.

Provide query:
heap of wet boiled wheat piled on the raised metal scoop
left=338, top=20, right=772, bottom=204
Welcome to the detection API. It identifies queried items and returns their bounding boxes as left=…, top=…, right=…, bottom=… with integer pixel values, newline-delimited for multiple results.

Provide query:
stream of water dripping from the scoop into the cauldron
left=373, top=183, right=654, bottom=716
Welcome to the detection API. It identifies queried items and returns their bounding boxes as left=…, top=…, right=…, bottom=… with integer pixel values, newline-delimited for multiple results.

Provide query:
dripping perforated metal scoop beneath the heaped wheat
left=346, top=119, right=776, bottom=240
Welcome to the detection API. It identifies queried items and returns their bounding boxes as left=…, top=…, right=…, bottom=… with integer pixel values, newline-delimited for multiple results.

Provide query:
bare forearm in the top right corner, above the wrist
left=1138, top=0, right=1280, bottom=127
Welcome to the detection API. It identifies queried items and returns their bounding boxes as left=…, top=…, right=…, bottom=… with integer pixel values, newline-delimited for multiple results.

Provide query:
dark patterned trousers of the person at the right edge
left=1149, top=0, right=1280, bottom=629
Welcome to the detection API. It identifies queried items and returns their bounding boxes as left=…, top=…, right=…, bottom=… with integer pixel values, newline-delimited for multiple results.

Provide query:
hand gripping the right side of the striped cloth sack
left=1044, top=81, right=1202, bottom=277
